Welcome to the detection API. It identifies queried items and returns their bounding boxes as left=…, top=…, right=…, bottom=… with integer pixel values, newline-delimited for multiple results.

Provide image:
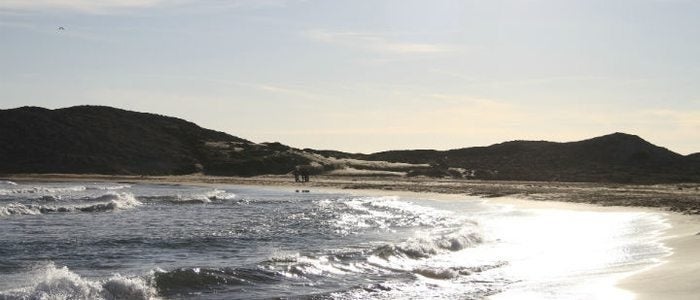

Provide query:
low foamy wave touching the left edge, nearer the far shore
left=0, top=193, right=142, bottom=216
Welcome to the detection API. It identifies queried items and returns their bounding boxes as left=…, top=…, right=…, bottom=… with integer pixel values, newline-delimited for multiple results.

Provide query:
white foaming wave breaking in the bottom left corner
left=0, top=263, right=156, bottom=300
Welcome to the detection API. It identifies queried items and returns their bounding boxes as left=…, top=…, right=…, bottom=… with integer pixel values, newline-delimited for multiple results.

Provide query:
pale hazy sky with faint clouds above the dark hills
left=0, top=0, right=700, bottom=154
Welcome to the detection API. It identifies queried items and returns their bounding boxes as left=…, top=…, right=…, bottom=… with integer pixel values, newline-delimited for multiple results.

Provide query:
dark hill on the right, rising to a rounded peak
left=364, top=133, right=700, bottom=183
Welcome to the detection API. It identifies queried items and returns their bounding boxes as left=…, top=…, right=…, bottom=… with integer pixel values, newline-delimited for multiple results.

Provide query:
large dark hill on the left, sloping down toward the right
left=0, top=106, right=303, bottom=175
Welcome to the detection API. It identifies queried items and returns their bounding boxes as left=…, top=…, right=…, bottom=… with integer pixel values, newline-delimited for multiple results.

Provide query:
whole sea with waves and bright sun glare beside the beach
left=0, top=181, right=670, bottom=299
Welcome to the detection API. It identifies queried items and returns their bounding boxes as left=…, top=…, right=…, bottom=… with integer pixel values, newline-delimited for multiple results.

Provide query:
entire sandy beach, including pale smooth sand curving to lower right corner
left=2, top=174, right=700, bottom=300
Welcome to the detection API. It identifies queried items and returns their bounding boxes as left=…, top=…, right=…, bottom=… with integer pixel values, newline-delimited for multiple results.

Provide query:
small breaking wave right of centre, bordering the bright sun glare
left=373, top=231, right=482, bottom=259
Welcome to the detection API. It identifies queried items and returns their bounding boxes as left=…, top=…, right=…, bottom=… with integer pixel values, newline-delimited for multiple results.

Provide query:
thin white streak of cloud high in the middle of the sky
left=303, top=29, right=454, bottom=54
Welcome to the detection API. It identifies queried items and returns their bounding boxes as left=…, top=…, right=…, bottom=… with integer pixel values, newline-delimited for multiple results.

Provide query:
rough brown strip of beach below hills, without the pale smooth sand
left=6, top=174, right=700, bottom=211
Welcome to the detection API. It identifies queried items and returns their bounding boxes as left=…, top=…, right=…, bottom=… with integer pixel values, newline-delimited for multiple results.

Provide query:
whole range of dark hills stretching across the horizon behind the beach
left=0, top=106, right=700, bottom=183
